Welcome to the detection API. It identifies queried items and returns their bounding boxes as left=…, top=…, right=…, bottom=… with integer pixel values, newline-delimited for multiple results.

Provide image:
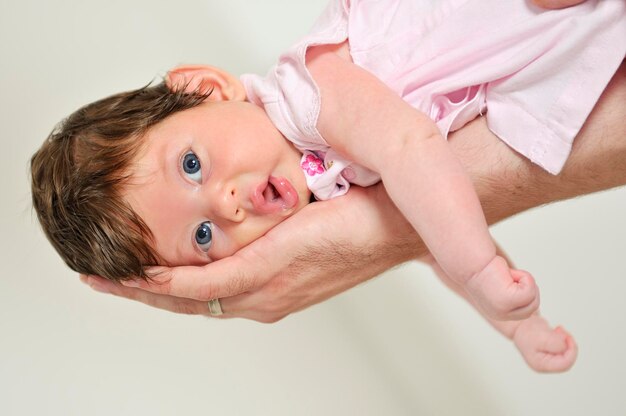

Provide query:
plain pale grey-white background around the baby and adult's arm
left=0, top=0, right=626, bottom=416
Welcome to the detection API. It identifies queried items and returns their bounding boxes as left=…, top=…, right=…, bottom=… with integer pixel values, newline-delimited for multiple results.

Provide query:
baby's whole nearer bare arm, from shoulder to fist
left=307, top=47, right=539, bottom=319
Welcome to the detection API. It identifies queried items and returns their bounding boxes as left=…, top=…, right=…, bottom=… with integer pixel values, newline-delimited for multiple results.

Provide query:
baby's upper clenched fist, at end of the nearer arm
left=466, top=256, right=539, bottom=321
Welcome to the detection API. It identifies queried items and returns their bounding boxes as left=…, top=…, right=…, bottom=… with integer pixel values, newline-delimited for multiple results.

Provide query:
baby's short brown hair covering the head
left=31, top=83, right=210, bottom=281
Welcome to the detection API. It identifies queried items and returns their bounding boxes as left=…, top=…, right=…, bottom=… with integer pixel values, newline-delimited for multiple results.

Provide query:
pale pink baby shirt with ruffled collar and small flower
left=241, top=0, right=626, bottom=199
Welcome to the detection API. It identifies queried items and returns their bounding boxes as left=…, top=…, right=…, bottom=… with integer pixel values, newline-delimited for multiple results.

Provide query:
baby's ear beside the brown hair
left=165, top=65, right=246, bottom=101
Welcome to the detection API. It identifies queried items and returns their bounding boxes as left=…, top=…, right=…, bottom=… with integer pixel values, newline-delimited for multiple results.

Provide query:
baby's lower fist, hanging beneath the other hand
left=513, top=315, right=578, bottom=373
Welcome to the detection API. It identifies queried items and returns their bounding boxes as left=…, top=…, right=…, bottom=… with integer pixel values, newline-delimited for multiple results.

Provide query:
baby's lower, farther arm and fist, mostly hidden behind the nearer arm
left=421, top=250, right=577, bottom=372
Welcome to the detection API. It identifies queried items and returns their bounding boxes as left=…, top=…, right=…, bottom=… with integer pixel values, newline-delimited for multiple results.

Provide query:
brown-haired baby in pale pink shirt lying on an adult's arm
left=32, top=0, right=625, bottom=365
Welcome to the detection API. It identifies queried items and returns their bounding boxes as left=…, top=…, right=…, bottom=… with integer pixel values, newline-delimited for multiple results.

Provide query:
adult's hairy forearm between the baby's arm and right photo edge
left=460, top=64, right=626, bottom=224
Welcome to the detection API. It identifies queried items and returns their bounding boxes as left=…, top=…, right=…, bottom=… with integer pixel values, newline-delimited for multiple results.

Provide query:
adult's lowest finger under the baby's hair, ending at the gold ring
left=81, top=275, right=209, bottom=316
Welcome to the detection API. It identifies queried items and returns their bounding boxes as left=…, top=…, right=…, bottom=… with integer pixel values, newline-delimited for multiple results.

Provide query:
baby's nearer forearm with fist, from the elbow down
left=381, top=134, right=539, bottom=320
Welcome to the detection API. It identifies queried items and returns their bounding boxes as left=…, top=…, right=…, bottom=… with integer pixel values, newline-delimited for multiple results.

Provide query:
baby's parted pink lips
left=251, top=176, right=299, bottom=214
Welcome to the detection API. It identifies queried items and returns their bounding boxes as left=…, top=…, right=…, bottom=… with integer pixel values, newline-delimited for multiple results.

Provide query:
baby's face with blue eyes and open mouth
left=125, top=101, right=309, bottom=266
